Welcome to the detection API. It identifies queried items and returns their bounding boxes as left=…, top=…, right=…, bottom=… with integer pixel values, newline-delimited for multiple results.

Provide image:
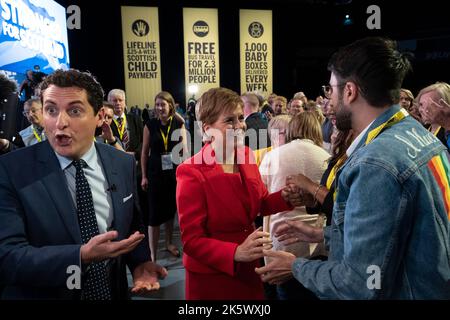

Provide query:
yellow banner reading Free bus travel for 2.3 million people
left=183, top=8, right=220, bottom=102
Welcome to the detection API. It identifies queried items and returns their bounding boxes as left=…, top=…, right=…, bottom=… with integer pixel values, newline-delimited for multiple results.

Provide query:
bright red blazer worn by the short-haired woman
left=176, top=144, right=292, bottom=299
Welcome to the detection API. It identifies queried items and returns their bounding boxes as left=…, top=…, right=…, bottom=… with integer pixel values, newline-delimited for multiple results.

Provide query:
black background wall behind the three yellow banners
left=57, top=0, right=450, bottom=105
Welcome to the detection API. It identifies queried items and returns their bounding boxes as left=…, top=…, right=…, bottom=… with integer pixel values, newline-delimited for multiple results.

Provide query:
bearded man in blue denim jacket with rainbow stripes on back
left=257, top=38, right=450, bottom=299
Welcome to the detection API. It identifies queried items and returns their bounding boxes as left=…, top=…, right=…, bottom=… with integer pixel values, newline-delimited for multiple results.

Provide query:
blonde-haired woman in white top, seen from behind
left=260, top=112, right=330, bottom=299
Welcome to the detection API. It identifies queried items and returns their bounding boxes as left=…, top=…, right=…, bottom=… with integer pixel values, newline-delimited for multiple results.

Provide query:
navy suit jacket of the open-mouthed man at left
left=0, top=141, right=150, bottom=299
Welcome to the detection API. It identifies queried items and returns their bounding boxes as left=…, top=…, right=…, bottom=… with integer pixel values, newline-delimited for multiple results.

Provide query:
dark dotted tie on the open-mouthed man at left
left=72, top=160, right=111, bottom=300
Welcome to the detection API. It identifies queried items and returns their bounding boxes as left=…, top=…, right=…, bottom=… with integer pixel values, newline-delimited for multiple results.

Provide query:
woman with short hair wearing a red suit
left=176, top=88, right=292, bottom=300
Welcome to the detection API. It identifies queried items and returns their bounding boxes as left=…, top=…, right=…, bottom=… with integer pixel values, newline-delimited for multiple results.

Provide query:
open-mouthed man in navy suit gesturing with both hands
left=0, top=70, right=167, bottom=300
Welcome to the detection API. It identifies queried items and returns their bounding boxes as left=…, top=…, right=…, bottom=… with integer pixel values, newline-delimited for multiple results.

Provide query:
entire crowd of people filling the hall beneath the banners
left=0, top=38, right=450, bottom=300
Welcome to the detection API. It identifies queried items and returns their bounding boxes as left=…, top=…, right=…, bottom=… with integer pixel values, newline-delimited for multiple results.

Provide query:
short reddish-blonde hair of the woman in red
left=196, top=88, right=244, bottom=125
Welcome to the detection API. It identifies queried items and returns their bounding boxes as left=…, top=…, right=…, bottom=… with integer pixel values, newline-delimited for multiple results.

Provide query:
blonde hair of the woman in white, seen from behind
left=286, top=112, right=323, bottom=147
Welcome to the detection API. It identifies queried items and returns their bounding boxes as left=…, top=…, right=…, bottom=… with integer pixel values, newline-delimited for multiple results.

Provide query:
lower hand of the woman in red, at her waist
left=234, top=227, right=272, bottom=262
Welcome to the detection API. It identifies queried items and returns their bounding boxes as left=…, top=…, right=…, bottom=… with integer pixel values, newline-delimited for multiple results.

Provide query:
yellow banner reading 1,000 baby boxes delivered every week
left=239, top=10, right=273, bottom=97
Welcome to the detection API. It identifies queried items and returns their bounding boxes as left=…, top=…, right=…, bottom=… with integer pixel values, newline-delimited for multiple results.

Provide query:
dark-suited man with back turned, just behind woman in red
left=242, top=92, right=270, bottom=151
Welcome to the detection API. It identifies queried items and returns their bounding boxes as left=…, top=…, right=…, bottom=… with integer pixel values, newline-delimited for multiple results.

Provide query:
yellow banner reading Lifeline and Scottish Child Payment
left=122, top=7, right=161, bottom=108
